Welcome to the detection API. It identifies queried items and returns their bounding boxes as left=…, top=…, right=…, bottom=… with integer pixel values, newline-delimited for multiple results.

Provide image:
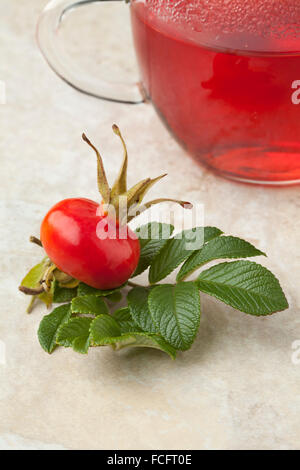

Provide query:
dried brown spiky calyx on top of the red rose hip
left=82, top=124, right=192, bottom=223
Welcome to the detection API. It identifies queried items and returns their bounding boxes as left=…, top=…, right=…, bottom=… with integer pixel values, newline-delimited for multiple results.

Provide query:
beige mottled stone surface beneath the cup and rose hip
left=0, top=0, right=300, bottom=449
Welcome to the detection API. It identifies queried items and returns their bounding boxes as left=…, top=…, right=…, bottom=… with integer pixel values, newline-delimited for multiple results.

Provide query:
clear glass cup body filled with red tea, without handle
left=131, top=0, right=300, bottom=183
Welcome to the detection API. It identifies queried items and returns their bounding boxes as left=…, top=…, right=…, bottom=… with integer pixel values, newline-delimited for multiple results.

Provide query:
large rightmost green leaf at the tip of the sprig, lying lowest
left=196, top=261, right=288, bottom=315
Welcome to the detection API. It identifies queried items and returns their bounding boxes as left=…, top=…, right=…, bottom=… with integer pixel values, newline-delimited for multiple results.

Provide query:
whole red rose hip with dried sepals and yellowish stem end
left=20, top=125, right=192, bottom=310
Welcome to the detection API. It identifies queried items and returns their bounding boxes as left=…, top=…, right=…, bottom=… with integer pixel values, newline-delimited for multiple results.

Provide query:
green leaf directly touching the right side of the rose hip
left=132, top=222, right=174, bottom=277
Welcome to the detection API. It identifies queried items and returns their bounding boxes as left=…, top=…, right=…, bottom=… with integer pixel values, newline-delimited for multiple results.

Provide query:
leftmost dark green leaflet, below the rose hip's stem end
left=38, top=304, right=71, bottom=354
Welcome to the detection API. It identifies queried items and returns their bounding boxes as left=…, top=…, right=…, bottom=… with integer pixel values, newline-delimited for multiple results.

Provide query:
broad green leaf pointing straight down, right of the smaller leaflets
left=148, top=282, right=200, bottom=351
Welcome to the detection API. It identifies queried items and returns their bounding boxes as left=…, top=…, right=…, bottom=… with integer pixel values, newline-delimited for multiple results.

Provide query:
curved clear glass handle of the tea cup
left=37, top=0, right=145, bottom=104
